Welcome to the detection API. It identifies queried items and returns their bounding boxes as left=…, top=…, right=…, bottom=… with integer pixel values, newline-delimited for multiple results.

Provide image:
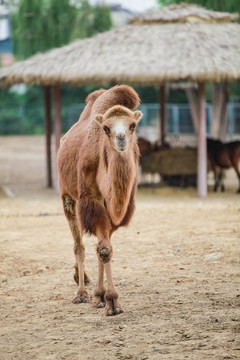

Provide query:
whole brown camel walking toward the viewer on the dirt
left=57, top=85, right=142, bottom=316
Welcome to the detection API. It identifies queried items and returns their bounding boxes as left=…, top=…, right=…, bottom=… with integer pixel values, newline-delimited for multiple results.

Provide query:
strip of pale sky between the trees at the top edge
left=91, top=0, right=158, bottom=12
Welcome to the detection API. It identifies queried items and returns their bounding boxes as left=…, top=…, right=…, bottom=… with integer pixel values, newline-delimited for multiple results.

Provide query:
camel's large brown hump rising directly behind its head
left=90, top=85, right=140, bottom=115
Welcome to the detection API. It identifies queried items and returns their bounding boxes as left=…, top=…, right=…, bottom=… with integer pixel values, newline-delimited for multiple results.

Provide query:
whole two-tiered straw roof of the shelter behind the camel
left=0, top=6, right=240, bottom=86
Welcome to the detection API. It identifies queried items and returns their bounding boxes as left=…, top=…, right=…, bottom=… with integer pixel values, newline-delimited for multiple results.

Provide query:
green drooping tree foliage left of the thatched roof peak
left=11, top=0, right=112, bottom=59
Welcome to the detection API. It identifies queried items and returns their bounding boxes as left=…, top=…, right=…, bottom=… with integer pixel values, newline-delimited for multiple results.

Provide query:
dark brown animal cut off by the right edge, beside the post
left=207, top=139, right=240, bottom=193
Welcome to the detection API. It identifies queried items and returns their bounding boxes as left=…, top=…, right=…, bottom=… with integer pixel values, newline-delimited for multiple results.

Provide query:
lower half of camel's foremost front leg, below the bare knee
left=104, top=261, right=123, bottom=316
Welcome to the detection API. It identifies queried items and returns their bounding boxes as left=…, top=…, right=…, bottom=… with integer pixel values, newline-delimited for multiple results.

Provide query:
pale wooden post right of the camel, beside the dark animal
left=197, top=83, right=207, bottom=198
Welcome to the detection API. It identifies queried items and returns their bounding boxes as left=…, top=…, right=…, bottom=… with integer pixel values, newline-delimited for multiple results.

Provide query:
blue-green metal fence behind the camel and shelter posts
left=0, top=102, right=240, bottom=138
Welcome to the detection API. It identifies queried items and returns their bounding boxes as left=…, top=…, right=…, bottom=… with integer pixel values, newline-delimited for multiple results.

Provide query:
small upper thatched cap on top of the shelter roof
left=129, top=3, right=239, bottom=24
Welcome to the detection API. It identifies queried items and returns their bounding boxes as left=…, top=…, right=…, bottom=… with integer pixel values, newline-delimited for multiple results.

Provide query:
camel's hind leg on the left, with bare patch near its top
left=63, top=195, right=90, bottom=304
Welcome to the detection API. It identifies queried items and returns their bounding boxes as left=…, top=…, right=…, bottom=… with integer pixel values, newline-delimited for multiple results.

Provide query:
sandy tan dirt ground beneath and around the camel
left=0, top=137, right=240, bottom=360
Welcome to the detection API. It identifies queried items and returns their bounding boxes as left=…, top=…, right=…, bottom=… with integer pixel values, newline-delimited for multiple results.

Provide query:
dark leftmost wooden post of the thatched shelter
left=44, top=86, right=52, bottom=188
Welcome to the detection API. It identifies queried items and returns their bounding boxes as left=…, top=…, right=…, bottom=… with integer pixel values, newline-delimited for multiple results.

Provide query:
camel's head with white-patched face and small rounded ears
left=95, top=105, right=143, bottom=152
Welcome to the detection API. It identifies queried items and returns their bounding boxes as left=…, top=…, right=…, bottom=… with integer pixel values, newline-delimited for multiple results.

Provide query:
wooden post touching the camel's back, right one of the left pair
left=54, top=85, right=62, bottom=193
